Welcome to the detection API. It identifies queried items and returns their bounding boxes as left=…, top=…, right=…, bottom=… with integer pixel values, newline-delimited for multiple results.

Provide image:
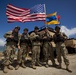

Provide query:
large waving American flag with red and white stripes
left=6, top=4, right=46, bottom=22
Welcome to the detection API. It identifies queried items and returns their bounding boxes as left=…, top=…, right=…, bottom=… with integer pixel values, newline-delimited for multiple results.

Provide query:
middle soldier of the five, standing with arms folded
left=30, top=26, right=41, bottom=69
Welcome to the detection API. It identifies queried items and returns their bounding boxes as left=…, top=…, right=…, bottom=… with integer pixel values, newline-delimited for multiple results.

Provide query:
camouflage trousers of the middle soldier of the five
left=32, top=46, right=40, bottom=65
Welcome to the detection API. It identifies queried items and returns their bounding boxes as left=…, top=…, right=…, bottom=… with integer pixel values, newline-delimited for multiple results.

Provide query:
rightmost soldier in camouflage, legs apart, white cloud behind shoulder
left=54, top=26, right=69, bottom=70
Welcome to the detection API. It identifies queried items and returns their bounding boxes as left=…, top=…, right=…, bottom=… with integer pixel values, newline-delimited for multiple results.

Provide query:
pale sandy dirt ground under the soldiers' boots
left=0, top=54, right=76, bottom=75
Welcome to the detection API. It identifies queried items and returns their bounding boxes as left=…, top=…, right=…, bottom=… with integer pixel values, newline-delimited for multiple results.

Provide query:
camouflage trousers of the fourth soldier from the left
left=43, top=42, right=55, bottom=64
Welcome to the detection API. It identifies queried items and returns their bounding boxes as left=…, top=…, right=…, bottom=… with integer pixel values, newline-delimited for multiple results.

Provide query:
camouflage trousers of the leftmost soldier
left=3, top=44, right=16, bottom=65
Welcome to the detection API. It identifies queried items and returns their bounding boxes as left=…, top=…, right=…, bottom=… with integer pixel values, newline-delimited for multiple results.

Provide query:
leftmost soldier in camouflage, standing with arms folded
left=3, top=26, right=20, bottom=73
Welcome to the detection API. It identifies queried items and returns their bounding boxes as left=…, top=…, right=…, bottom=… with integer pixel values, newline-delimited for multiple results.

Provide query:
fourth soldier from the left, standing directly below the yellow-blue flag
left=42, top=28, right=56, bottom=68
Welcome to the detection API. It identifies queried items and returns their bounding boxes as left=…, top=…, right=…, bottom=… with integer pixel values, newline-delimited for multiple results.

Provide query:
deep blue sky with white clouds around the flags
left=0, top=0, right=76, bottom=45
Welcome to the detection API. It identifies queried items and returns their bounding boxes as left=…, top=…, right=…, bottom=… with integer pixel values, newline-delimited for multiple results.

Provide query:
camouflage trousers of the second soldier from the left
left=17, top=45, right=27, bottom=64
